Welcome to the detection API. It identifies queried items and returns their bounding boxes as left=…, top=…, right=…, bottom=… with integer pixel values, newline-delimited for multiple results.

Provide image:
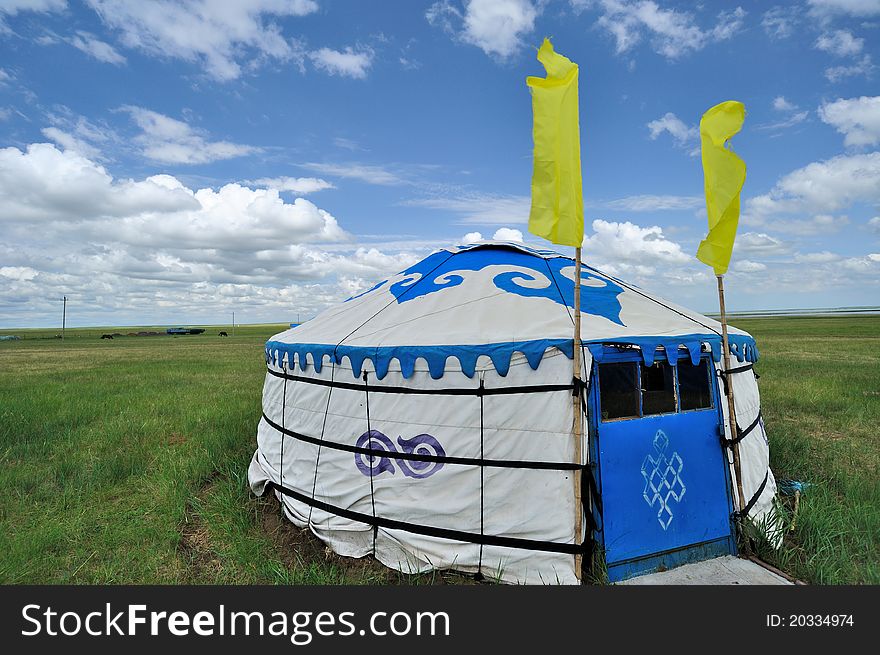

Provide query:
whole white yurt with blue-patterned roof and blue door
left=248, top=242, right=776, bottom=584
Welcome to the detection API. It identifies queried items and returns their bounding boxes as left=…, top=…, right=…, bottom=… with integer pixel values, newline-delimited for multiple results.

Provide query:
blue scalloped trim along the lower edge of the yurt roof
left=266, top=334, right=758, bottom=380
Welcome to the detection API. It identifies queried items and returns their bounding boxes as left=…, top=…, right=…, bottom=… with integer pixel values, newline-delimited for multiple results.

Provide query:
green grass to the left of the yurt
left=0, top=325, right=474, bottom=584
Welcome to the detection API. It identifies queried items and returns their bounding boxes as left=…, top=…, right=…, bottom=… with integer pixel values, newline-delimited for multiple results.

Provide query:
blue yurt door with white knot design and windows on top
left=589, top=347, right=736, bottom=582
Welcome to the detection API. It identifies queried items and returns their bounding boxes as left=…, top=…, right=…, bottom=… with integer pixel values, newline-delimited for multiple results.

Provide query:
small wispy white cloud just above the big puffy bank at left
left=122, top=105, right=260, bottom=164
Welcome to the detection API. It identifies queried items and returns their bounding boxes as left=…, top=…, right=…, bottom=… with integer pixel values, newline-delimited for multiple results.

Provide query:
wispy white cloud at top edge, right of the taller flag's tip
left=572, top=0, right=746, bottom=59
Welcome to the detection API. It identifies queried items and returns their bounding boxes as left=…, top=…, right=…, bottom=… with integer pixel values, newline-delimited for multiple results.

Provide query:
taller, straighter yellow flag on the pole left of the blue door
left=526, top=39, right=584, bottom=247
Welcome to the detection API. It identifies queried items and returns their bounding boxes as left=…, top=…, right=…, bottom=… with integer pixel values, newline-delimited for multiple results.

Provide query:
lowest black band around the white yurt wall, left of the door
left=264, top=481, right=585, bottom=555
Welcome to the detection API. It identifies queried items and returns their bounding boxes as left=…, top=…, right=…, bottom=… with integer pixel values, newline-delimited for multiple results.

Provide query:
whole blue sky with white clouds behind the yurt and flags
left=0, top=0, right=880, bottom=328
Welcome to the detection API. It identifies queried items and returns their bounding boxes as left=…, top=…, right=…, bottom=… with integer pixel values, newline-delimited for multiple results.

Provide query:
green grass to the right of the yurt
left=736, top=316, right=880, bottom=584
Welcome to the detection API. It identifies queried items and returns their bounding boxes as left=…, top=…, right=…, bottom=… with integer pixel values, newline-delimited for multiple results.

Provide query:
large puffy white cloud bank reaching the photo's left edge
left=0, top=144, right=346, bottom=245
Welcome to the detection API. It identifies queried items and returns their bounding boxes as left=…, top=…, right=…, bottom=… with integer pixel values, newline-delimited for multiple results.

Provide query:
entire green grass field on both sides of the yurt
left=0, top=316, right=880, bottom=584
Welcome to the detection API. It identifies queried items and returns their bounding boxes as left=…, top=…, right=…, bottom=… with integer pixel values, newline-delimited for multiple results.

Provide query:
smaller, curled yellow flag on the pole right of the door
left=697, top=100, right=746, bottom=275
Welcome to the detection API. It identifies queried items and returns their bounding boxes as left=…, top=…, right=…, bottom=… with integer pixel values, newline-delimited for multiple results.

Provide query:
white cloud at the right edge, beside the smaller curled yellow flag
left=747, top=152, right=880, bottom=217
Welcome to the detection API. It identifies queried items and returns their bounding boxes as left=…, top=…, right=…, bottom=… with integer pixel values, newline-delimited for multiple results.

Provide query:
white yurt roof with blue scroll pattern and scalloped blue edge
left=266, top=241, right=758, bottom=379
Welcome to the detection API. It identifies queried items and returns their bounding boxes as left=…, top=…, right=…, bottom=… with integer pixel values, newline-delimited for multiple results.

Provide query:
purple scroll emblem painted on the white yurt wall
left=354, top=430, right=446, bottom=478
